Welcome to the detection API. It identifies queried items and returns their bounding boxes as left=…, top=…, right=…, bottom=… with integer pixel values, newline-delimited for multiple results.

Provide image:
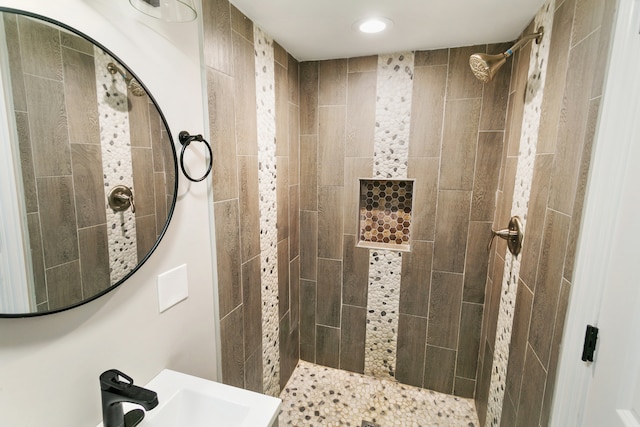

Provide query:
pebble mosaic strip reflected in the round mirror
left=94, top=47, right=138, bottom=284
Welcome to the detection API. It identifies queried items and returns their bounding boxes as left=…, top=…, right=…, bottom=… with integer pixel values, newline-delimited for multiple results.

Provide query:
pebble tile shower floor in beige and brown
left=278, top=361, right=480, bottom=427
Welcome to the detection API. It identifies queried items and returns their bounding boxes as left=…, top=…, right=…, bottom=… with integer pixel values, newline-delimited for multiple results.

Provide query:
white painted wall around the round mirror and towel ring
left=0, top=0, right=216, bottom=427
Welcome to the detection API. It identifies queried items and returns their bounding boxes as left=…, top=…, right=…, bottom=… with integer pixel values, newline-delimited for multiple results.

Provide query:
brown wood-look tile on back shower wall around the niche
left=300, top=45, right=510, bottom=397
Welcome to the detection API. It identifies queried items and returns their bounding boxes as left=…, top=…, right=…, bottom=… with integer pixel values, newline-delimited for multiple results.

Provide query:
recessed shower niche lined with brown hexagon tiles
left=357, top=179, right=414, bottom=252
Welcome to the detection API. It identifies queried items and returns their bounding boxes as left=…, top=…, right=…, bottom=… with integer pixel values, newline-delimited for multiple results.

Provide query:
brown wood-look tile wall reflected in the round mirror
left=3, top=14, right=175, bottom=311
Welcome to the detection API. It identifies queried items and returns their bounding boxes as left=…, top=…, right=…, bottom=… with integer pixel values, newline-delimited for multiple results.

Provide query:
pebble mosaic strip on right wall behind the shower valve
left=486, top=0, right=555, bottom=427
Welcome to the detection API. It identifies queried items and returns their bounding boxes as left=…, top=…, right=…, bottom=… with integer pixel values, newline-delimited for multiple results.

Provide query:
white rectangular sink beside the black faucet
left=98, top=369, right=281, bottom=427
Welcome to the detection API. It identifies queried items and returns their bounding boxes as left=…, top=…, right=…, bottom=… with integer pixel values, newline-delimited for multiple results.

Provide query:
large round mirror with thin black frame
left=0, top=8, right=177, bottom=317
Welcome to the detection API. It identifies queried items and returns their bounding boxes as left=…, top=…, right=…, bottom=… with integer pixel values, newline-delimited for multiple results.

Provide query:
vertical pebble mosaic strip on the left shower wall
left=253, top=25, right=280, bottom=396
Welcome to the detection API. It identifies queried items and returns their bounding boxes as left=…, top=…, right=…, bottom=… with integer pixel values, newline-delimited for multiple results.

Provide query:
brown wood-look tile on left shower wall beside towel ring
left=203, top=0, right=300, bottom=392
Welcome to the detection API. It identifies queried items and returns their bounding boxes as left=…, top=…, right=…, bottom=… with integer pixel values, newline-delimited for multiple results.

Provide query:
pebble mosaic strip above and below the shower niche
left=364, top=52, right=414, bottom=378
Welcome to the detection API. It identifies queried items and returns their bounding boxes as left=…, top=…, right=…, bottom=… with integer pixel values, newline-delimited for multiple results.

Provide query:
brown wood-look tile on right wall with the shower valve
left=476, top=0, right=616, bottom=427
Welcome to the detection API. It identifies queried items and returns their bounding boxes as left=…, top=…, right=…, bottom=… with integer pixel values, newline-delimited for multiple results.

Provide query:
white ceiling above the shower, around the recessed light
left=231, top=0, right=545, bottom=61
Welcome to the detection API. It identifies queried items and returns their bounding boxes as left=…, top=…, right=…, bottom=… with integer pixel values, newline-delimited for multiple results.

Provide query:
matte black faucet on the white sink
left=100, top=369, right=158, bottom=427
